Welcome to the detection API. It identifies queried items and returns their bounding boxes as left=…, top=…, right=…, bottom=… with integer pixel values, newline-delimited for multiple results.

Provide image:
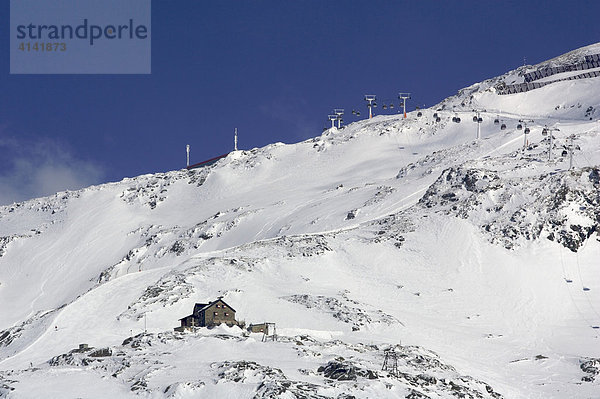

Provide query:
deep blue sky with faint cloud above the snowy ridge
left=0, top=0, right=600, bottom=204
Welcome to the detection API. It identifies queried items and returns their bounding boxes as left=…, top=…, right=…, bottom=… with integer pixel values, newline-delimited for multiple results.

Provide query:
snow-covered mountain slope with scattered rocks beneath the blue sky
left=0, top=45, right=600, bottom=398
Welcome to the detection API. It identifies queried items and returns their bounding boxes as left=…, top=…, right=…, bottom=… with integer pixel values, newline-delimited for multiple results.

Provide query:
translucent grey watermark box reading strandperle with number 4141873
left=10, top=0, right=152, bottom=74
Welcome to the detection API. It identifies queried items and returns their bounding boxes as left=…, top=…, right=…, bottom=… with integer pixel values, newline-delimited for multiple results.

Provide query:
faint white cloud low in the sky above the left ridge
left=0, top=138, right=103, bottom=205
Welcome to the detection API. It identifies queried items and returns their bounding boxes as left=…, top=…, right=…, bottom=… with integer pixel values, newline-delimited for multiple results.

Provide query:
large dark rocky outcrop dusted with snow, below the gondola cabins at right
left=418, top=167, right=600, bottom=252
